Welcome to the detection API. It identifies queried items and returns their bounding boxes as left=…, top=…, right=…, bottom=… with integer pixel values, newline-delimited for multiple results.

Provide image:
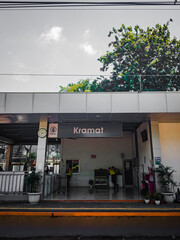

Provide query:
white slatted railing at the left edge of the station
left=0, top=171, right=25, bottom=194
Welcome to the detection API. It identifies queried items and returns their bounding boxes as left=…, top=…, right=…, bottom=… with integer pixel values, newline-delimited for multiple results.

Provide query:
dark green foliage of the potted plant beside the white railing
left=25, top=171, right=42, bottom=193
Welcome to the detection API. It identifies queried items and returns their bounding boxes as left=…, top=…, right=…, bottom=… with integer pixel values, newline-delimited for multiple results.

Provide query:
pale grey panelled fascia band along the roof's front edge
left=0, top=91, right=180, bottom=114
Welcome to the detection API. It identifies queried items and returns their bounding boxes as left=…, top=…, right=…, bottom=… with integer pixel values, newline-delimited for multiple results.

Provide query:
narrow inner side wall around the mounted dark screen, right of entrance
left=137, top=122, right=152, bottom=181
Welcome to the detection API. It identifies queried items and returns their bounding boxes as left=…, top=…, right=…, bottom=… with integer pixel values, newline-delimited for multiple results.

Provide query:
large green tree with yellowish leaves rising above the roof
left=97, top=19, right=180, bottom=91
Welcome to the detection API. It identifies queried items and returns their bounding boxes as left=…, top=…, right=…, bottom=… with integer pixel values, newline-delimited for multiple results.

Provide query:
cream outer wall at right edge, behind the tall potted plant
left=159, top=123, right=180, bottom=188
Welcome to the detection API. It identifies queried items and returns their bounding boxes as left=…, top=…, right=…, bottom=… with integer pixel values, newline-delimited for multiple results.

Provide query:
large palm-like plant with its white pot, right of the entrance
left=156, top=164, right=176, bottom=203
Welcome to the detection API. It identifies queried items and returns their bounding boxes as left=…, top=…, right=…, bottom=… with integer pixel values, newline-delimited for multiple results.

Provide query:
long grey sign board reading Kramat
left=58, top=123, right=122, bottom=138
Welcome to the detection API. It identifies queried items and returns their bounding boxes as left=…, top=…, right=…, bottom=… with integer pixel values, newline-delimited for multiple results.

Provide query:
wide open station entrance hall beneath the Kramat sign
left=45, top=138, right=140, bottom=200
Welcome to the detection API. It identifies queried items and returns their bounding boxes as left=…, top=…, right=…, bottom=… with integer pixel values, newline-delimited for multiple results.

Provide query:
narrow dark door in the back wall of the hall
left=124, top=160, right=133, bottom=187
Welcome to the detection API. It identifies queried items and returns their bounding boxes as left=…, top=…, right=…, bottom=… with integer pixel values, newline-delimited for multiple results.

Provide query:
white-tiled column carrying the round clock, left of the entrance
left=36, top=116, right=48, bottom=192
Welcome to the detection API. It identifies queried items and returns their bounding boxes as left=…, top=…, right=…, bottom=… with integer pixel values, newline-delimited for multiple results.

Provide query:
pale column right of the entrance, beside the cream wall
left=151, top=121, right=161, bottom=192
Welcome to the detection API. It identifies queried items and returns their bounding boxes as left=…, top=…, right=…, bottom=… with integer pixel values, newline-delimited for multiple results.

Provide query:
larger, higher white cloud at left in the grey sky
left=40, top=26, right=63, bottom=43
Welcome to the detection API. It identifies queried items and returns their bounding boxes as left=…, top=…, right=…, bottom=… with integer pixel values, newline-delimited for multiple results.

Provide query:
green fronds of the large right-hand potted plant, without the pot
left=156, top=164, right=176, bottom=192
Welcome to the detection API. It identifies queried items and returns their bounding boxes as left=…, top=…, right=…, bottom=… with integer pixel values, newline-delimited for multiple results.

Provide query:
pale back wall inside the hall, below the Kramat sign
left=63, top=132, right=135, bottom=186
